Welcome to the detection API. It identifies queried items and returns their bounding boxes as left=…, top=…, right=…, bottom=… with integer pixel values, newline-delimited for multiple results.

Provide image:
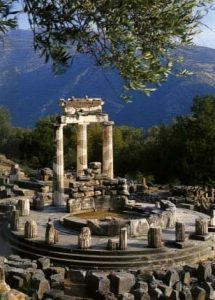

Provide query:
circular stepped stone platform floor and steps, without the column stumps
left=4, top=207, right=214, bottom=270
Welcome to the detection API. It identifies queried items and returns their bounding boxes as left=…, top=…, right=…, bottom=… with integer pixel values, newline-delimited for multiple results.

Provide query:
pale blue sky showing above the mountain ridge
left=19, top=4, right=215, bottom=48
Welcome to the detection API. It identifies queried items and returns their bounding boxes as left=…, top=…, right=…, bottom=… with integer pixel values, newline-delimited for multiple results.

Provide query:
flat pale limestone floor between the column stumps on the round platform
left=10, top=206, right=209, bottom=250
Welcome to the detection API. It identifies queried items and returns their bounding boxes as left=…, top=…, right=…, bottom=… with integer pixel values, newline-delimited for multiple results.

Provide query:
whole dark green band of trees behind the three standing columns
left=0, top=96, right=215, bottom=184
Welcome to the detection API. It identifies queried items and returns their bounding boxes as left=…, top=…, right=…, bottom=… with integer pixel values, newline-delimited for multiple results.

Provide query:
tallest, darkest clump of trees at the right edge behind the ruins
left=144, top=96, right=215, bottom=184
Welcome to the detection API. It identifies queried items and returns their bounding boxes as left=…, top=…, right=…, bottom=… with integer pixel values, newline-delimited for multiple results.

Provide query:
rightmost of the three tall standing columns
left=102, top=121, right=114, bottom=179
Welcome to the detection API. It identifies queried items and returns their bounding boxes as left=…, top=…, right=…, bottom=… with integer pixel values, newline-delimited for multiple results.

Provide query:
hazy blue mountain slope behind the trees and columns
left=0, top=30, right=215, bottom=127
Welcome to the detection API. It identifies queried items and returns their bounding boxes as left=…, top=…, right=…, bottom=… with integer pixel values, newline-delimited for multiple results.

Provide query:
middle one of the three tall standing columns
left=77, top=124, right=88, bottom=176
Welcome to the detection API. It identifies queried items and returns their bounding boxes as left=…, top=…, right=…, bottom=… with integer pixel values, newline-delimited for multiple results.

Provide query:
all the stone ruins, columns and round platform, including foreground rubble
left=0, top=98, right=215, bottom=300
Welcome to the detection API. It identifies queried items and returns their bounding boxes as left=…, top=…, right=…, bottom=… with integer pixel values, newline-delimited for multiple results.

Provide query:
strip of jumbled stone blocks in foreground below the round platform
left=0, top=255, right=215, bottom=300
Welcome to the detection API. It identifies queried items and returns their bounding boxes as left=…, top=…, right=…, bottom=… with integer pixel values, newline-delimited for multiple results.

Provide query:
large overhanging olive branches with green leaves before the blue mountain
left=23, top=0, right=213, bottom=94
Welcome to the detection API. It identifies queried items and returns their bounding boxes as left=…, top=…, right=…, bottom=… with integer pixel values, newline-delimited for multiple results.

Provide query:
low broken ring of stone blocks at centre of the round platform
left=63, top=197, right=176, bottom=237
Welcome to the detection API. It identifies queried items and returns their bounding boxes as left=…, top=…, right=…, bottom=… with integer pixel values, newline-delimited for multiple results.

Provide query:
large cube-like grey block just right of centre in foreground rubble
left=108, top=272, right=135, bottom=295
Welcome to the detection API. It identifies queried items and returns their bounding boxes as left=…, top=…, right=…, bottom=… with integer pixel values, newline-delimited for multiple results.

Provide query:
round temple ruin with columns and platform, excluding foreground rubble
left=0, top=98, right=215, bottom=270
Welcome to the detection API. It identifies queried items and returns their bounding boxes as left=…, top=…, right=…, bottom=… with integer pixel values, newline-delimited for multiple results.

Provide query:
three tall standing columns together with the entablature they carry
left=53, top=98, right=113, bottom=206
